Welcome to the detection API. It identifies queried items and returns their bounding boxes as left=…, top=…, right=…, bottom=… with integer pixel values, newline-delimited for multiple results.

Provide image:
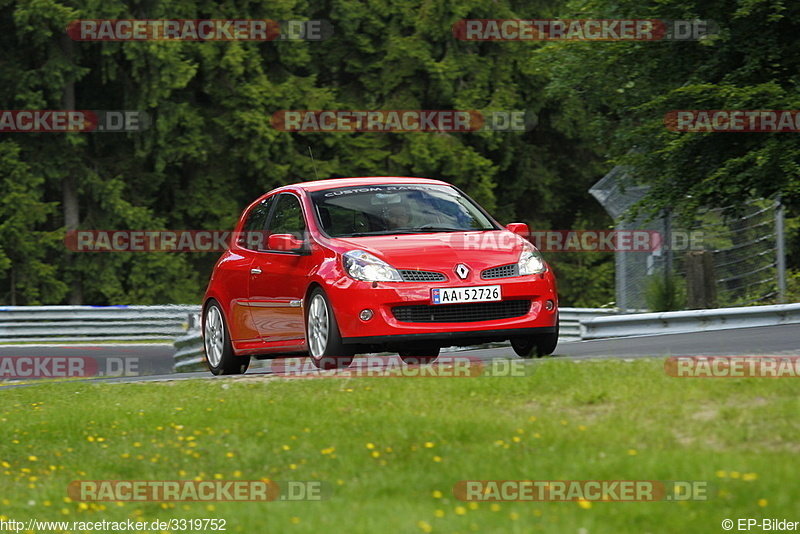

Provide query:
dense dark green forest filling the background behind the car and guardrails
left=0, top=0, right=800, bottom=306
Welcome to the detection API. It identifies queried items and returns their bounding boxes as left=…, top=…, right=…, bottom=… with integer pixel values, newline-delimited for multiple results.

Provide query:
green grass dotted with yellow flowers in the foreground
left=0, top=359, right=800, bottom=534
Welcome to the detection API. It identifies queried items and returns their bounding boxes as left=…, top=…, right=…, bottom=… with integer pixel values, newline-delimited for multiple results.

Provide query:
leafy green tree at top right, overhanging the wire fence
left=533, top=0, right=800, bottom=222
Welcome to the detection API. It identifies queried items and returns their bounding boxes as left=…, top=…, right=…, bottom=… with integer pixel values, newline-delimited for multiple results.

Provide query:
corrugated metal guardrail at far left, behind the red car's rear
left=0, top=305, right=200, bottom=343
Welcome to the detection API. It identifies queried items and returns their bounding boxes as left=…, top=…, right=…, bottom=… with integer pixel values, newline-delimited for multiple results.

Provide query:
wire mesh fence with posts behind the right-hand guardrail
left=590, top=167, right=785, bottom=311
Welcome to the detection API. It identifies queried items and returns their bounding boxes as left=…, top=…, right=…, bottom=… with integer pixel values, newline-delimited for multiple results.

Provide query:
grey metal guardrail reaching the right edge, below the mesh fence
left=581, top=304, right=800, bottom=339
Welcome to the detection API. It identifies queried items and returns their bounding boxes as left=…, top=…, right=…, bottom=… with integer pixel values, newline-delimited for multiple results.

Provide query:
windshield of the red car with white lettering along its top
left=311, top=184, right=497, bottom=237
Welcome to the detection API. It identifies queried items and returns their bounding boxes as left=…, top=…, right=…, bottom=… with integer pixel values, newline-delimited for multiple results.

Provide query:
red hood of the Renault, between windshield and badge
left=332, top=230, right=526, bottom=271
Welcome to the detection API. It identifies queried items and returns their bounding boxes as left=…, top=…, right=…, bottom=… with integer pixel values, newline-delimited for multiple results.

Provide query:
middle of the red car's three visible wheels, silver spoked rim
left=306, top=287, right=353, bottom=369
